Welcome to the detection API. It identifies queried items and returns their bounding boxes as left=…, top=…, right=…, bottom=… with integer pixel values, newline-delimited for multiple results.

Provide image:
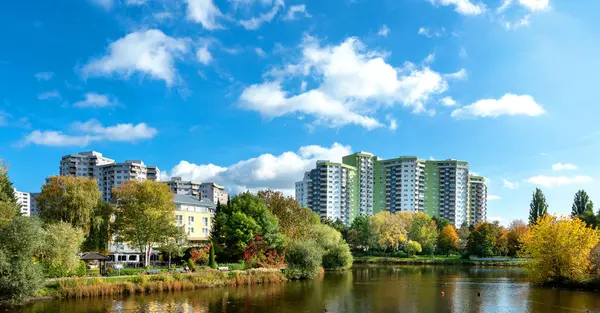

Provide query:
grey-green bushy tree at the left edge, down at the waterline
left=0, top=216, right=44, bottom=304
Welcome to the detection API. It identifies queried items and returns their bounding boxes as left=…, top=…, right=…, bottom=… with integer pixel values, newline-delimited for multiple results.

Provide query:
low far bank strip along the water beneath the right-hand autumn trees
left=354, top=256, right=527, bottom=266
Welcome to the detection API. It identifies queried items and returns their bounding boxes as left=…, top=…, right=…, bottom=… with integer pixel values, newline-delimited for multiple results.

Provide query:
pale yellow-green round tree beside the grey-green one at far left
left=37, top=222, right=84, bottom=277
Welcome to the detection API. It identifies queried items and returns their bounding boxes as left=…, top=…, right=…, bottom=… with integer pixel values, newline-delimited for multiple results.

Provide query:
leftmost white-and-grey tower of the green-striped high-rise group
left=296, top=161, right=359, bottom=225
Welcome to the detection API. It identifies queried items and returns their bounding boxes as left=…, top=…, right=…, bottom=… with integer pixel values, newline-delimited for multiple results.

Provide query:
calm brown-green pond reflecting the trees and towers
left=7, top=266, right=600, bottom=313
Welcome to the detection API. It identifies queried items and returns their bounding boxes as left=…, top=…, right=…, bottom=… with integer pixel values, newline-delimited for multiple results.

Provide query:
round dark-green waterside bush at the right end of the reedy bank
left=285, top=241, right=323, bottom=279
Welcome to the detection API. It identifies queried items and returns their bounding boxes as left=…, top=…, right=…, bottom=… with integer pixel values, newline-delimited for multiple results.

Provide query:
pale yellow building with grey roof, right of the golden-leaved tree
left=174, top=195, right=217, bottom=243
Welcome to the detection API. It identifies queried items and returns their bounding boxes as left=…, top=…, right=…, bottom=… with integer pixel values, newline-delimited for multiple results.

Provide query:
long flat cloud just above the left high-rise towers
left=21, top=119, right=158, bottom=147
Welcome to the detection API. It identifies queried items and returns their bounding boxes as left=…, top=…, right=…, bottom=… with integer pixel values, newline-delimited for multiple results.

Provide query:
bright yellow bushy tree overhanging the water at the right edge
left=524, top=215, right=600, bottom=283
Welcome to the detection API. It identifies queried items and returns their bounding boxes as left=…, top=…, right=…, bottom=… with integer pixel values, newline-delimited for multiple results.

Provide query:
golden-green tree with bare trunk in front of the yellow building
left=113, top=180, right=179, bottom=266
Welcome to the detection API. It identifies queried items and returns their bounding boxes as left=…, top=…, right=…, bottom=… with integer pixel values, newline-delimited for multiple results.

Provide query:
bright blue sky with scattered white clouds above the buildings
left=0, top=0, right=600, bottom=221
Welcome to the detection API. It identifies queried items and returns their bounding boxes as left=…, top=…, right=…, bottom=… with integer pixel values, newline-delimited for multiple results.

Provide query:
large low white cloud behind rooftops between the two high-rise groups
left=161, top=143, right=351, bottom=195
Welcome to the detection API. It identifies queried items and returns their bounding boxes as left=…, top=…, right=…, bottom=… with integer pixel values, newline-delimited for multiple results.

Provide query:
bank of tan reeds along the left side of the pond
left=36, top=268, right=287, bottom=299
